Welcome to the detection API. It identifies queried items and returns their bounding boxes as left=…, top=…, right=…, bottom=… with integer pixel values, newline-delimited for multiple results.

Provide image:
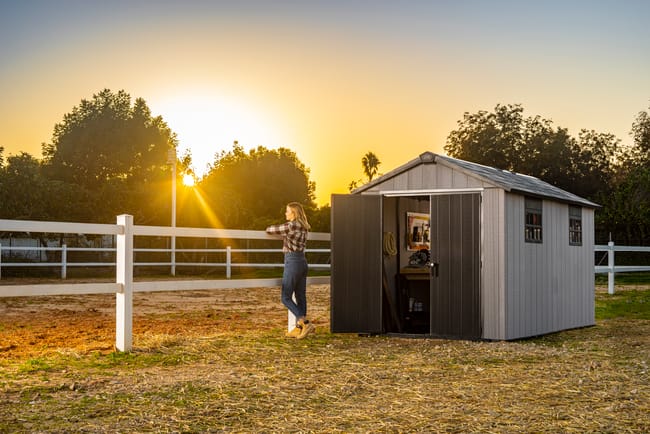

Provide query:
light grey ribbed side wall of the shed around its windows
left=505, top=193, right=594, bottom=339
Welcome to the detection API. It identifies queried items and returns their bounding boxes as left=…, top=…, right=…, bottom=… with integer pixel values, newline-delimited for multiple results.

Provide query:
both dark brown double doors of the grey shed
left=331, top=194, right=481, bottom=339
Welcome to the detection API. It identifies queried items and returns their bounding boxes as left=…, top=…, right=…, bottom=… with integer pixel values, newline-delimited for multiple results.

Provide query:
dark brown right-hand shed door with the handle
left=431, top=194, right=481, bottom=339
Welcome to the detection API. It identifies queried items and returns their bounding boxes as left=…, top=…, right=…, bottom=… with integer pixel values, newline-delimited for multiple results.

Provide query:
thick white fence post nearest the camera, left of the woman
left=115, top=214, right=133, bottom=351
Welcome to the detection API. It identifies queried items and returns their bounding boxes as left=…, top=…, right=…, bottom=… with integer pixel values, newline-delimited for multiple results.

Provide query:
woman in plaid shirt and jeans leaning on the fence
left=266, top=202, right=316, bottom=339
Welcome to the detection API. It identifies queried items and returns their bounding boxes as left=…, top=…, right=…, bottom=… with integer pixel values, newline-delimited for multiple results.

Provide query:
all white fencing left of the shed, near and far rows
left=0, top=215, right=330, bottom=351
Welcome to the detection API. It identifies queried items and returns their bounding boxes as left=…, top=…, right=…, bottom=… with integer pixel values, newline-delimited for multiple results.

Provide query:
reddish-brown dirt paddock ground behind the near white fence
left=0, top=285, right=329, bottom=360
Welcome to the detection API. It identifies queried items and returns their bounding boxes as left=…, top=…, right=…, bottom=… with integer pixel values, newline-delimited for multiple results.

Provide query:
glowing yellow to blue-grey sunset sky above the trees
left=0, top=0, right=650, bottom=204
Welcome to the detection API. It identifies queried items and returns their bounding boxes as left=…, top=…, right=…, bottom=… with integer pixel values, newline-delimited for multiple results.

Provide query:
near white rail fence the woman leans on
left=0, top=214, right=330, bottom=351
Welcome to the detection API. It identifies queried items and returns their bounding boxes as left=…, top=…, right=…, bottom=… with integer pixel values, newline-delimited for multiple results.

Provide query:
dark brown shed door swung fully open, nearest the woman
left=330, top=194, right=382, bottom=333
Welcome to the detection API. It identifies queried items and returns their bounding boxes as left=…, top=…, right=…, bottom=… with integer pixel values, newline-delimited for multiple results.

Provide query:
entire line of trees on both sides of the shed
left=0, top=89, right=650, bottom=245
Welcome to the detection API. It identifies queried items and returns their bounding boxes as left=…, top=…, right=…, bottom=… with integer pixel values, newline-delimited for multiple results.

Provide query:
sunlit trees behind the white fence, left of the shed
left=0, top=89, right=329, bottom=231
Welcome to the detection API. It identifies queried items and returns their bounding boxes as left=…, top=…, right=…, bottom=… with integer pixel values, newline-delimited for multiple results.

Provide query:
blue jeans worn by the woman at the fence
left=282, top=252, right=307, bottom=318
